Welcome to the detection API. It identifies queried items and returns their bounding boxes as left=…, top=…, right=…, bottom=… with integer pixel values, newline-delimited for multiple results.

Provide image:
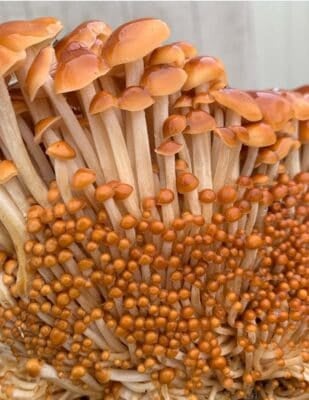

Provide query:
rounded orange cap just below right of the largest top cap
left=141, top=65, right=187, bottom=96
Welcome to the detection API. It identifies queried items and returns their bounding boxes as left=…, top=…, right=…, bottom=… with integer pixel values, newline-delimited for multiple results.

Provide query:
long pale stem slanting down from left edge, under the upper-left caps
left=0, top=77, right=47, bottom=206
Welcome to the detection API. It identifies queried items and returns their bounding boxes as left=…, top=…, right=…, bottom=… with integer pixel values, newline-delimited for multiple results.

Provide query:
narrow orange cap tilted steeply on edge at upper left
left=25, top=46, right=55, bottom=101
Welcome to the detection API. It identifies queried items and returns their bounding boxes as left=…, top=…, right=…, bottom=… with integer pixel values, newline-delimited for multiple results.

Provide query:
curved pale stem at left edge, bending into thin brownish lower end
left=0, top=187, right=28, bottom=293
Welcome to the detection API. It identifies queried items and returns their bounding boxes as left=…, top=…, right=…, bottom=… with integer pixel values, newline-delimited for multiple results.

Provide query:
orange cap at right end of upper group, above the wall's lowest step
left=183, top=56, right=225, bottom=90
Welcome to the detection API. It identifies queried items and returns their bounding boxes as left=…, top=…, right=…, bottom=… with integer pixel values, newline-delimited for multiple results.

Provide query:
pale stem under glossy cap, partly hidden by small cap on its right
left=80, top=84, right=118, bottom=183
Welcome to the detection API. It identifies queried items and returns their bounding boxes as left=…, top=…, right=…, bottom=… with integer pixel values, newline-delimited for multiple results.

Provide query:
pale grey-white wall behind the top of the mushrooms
left=0, top=1, right=309, bottom=88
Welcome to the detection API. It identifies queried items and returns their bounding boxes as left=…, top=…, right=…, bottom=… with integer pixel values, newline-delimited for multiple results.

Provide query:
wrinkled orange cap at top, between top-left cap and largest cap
left=55, top=20, right=112, bottom=58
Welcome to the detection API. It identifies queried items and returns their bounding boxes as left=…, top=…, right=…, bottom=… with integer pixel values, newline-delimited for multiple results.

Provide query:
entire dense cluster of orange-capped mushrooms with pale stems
left=0, top=18, right=309, bottom=400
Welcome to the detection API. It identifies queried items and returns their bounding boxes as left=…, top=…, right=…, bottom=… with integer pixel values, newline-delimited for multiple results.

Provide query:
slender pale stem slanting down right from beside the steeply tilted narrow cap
left=44, top=78, right=104, bottom=182
